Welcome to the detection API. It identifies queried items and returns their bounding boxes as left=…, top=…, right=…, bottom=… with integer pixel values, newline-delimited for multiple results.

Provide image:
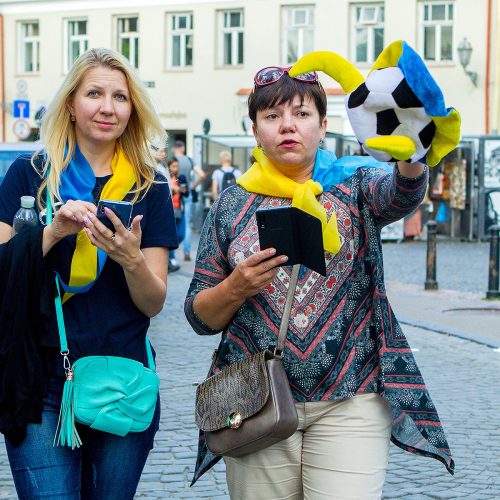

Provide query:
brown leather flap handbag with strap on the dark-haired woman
left=195, top=265, right=300, bottom=457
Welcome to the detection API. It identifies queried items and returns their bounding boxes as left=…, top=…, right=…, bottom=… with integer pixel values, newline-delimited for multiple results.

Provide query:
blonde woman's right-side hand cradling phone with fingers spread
left=84, top=207, right=144, bottom=270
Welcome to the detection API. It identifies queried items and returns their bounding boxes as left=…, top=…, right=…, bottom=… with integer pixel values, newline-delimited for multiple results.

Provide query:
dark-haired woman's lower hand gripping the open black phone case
left=226, top=248, right=288, bottom=301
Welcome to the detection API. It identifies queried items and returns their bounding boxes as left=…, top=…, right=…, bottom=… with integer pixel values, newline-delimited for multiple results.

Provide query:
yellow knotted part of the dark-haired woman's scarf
left=236, top=148, right=342, bottom=254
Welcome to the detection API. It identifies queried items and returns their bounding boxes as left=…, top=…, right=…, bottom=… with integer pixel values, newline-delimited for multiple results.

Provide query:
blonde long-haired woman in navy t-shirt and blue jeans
left=0, top=49, right=177, bottom=500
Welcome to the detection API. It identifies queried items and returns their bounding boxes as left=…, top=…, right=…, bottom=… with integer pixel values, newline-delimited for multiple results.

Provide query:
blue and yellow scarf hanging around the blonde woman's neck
left=58, top=145, right=136, bottom=302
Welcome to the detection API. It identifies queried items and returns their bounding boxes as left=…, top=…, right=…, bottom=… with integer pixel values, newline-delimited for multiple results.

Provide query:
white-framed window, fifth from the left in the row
left=219, top=10, right=244, bottom=66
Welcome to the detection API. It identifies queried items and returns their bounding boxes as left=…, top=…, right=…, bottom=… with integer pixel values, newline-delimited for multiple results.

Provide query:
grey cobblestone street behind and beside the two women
left=0, top=238, right=500, bottom=500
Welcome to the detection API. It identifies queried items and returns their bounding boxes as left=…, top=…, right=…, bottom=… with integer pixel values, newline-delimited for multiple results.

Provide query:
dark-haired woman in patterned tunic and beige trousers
left=185, top=67, right=453, bottom=500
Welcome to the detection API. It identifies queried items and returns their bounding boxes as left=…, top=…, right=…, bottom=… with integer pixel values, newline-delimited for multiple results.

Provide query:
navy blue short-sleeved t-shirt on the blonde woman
left=0, top=156, right=178, bottom=371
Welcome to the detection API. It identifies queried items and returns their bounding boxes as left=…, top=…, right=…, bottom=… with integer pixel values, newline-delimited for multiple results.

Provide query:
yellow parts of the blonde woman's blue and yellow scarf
left=63, top=147, right=136, bottom=302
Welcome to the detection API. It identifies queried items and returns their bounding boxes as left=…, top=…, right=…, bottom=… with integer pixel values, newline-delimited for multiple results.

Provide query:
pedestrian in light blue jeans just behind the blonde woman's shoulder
left=172, top=140, right=206, bottom=261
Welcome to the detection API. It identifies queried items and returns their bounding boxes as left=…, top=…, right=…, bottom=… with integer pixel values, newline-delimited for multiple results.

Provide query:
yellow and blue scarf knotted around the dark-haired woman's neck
left=236, top=148, right=392, bottom=254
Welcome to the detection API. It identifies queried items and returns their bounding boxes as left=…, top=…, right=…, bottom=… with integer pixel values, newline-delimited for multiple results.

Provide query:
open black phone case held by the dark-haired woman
left=255, top=207, right=326, bottom=276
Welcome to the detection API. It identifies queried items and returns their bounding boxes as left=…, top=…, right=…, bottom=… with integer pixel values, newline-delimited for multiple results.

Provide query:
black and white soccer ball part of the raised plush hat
left=346, top=67, right=436, bottom=162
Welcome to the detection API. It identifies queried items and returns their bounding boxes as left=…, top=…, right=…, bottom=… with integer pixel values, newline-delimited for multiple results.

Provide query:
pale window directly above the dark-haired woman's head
left=282, top=5, right=314, bottom=64
